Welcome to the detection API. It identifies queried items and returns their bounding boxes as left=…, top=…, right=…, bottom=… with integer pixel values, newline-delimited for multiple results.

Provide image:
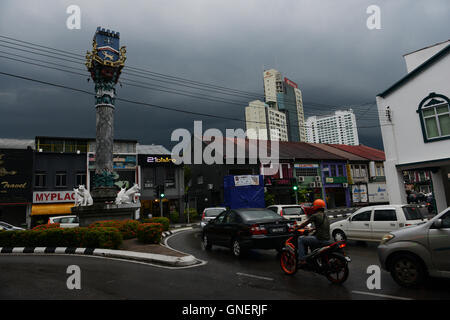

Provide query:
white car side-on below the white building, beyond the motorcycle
left=330, top=205, right=427, bottom=242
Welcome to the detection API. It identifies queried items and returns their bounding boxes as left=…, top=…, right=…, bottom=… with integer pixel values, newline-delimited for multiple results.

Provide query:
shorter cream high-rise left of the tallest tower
left=245, top=100, right=288, bottom=141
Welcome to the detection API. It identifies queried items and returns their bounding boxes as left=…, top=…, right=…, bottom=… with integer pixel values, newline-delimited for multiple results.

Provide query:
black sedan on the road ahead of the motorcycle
left=202, top=209, right=291, bottom=257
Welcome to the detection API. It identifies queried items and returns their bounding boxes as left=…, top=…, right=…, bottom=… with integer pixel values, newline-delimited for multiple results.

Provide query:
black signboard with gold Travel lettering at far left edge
left=0, top=149, right=33, bottom=203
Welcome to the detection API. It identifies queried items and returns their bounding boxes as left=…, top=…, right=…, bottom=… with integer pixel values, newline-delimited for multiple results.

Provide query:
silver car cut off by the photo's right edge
left=378, top=208, right=450, bottom=287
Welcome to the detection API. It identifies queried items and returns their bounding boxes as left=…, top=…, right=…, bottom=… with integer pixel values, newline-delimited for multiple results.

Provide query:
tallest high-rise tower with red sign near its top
left=264, top=69, right=306, bottom=142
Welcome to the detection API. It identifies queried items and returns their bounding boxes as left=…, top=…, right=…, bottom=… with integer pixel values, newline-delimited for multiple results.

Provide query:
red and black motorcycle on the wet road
left=280, top=229, right=351, bottom=284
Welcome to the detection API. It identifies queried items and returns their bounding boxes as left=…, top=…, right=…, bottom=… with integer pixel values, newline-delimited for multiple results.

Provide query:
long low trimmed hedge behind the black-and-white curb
left=0, top=228, right=123, bottom=249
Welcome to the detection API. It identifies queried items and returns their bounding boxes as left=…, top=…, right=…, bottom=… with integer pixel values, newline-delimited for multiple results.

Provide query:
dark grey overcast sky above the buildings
left=0, top=0, right=450, bottom=148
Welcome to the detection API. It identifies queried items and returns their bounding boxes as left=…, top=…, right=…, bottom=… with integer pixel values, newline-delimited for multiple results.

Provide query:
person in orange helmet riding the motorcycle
left=298, top=199, right=330, bottom=264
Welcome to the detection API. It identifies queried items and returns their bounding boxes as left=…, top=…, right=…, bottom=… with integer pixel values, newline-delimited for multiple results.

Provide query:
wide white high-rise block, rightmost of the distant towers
left=306, top=109, right=359, bottom=146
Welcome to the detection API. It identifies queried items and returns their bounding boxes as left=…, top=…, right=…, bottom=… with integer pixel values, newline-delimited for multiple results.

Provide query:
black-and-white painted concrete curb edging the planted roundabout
left=0, top=247, right=200, bottom=267
